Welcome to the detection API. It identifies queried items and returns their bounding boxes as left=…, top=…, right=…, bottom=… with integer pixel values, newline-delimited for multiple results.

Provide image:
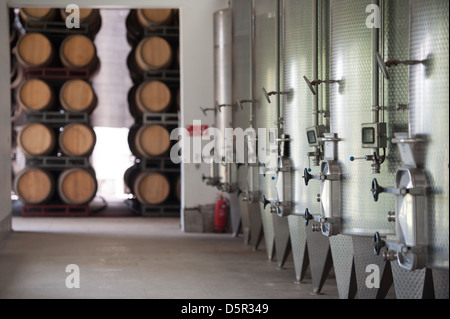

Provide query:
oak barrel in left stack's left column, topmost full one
left=16, top=33, right=54, bottom=68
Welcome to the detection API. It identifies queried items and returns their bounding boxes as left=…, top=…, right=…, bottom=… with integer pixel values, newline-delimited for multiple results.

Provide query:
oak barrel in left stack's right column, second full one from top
left=59, top=79, right=97, bottom=114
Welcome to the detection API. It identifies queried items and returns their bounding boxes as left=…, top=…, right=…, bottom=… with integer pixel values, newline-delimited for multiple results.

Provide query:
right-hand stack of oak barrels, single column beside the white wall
left=124, top=9, right=180, bottom=216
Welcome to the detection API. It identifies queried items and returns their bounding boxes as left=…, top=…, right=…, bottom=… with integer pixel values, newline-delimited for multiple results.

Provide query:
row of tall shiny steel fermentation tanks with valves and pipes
left=206, top=0, right=449, bottom=298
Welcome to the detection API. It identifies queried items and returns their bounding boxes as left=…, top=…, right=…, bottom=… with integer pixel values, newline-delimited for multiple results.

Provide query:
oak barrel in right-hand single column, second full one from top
left=136, top=81, right=172, bottom=113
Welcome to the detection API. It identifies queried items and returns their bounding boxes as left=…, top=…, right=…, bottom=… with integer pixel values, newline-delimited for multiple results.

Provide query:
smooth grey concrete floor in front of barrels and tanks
left=0, top=216, right=338, bottom=299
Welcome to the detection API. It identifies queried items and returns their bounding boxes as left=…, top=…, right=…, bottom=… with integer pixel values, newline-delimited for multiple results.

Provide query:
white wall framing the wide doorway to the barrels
left=0, top=0, right=228, bottom=235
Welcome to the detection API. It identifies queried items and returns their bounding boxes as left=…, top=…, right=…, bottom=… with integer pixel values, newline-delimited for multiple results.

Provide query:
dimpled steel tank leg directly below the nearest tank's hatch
left=391, top=261, right=434, bottom=299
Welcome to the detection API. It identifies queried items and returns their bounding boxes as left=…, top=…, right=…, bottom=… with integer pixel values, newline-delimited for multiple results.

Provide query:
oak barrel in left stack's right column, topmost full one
left=59, top=34, right=99, bottom=73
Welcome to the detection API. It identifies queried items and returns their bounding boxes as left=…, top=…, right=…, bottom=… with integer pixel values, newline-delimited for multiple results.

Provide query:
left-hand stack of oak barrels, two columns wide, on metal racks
left=14, top=8, right=101, bottom=215
